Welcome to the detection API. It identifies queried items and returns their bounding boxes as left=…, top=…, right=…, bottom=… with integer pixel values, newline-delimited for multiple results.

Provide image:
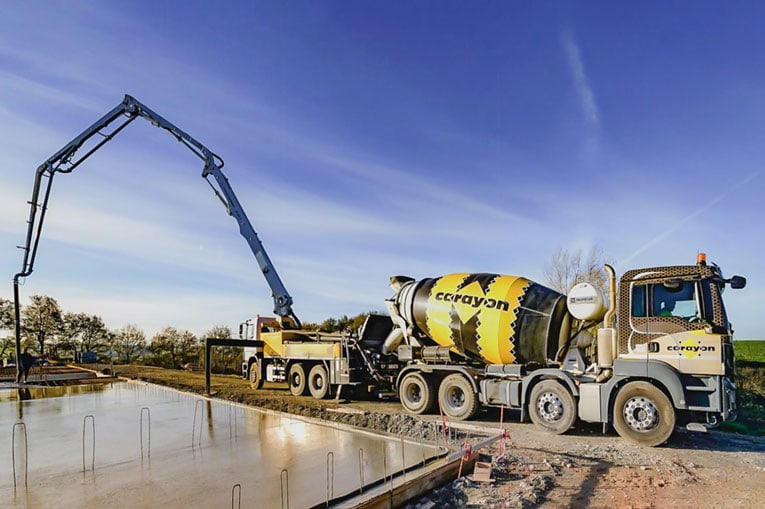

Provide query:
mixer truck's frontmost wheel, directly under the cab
left=614, top=382, right=676, bottom=447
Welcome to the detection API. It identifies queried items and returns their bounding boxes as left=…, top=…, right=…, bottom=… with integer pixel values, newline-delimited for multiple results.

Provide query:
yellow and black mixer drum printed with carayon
left=391, top=274, right=570, bottom=365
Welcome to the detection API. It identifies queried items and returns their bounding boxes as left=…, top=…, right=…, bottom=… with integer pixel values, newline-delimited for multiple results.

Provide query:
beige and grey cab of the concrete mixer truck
left=614, top=259, right=746, bottom=427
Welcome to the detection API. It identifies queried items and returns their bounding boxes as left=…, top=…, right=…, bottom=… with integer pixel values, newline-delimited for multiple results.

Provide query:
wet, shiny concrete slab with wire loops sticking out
left=0, top=383, right=438, bottom=508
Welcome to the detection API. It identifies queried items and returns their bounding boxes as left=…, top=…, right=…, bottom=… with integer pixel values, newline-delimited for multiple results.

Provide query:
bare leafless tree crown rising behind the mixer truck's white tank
left=544, top=245, right=608, bottom=294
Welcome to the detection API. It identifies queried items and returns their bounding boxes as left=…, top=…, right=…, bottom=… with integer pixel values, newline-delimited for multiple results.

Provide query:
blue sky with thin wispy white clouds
left=0, top=1, right=765, bottom=338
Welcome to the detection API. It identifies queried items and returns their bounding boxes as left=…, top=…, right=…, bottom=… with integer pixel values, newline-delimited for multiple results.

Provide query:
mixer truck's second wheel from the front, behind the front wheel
left=529, top=380, right=577, bottom=435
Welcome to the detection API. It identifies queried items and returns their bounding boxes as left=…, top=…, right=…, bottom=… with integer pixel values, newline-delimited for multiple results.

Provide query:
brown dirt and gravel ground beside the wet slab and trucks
left=107, top=366, right=765, bottom=509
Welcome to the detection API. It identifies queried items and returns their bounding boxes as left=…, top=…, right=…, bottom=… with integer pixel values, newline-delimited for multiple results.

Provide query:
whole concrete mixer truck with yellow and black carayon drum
left=381, top=255, right=746, bottom=446
